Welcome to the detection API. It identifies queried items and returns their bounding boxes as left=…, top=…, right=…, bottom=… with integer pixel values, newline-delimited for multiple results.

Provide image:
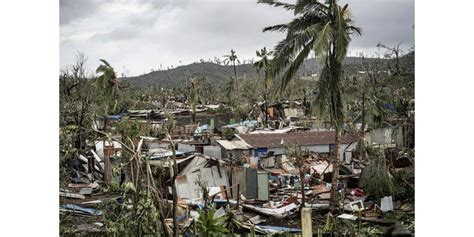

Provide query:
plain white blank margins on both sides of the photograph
left=0, top=0, right=474, bottom=236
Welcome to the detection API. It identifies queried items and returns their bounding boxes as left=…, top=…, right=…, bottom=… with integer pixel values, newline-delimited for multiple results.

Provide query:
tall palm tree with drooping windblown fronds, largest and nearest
left=259, top=0, right=361, bottom=210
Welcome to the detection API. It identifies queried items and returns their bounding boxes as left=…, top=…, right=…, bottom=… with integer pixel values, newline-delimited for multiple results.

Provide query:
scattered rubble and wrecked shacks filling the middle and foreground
left=59, top=98, right=413, bottom=234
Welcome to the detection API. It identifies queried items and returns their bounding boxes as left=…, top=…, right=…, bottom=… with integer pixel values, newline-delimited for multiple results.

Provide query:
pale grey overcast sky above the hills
left=60, top=0, right=414, bottom=76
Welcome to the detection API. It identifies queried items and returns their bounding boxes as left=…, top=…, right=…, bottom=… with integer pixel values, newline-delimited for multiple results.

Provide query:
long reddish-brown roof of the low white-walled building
left=238, top=131, right=359, bottom=148
